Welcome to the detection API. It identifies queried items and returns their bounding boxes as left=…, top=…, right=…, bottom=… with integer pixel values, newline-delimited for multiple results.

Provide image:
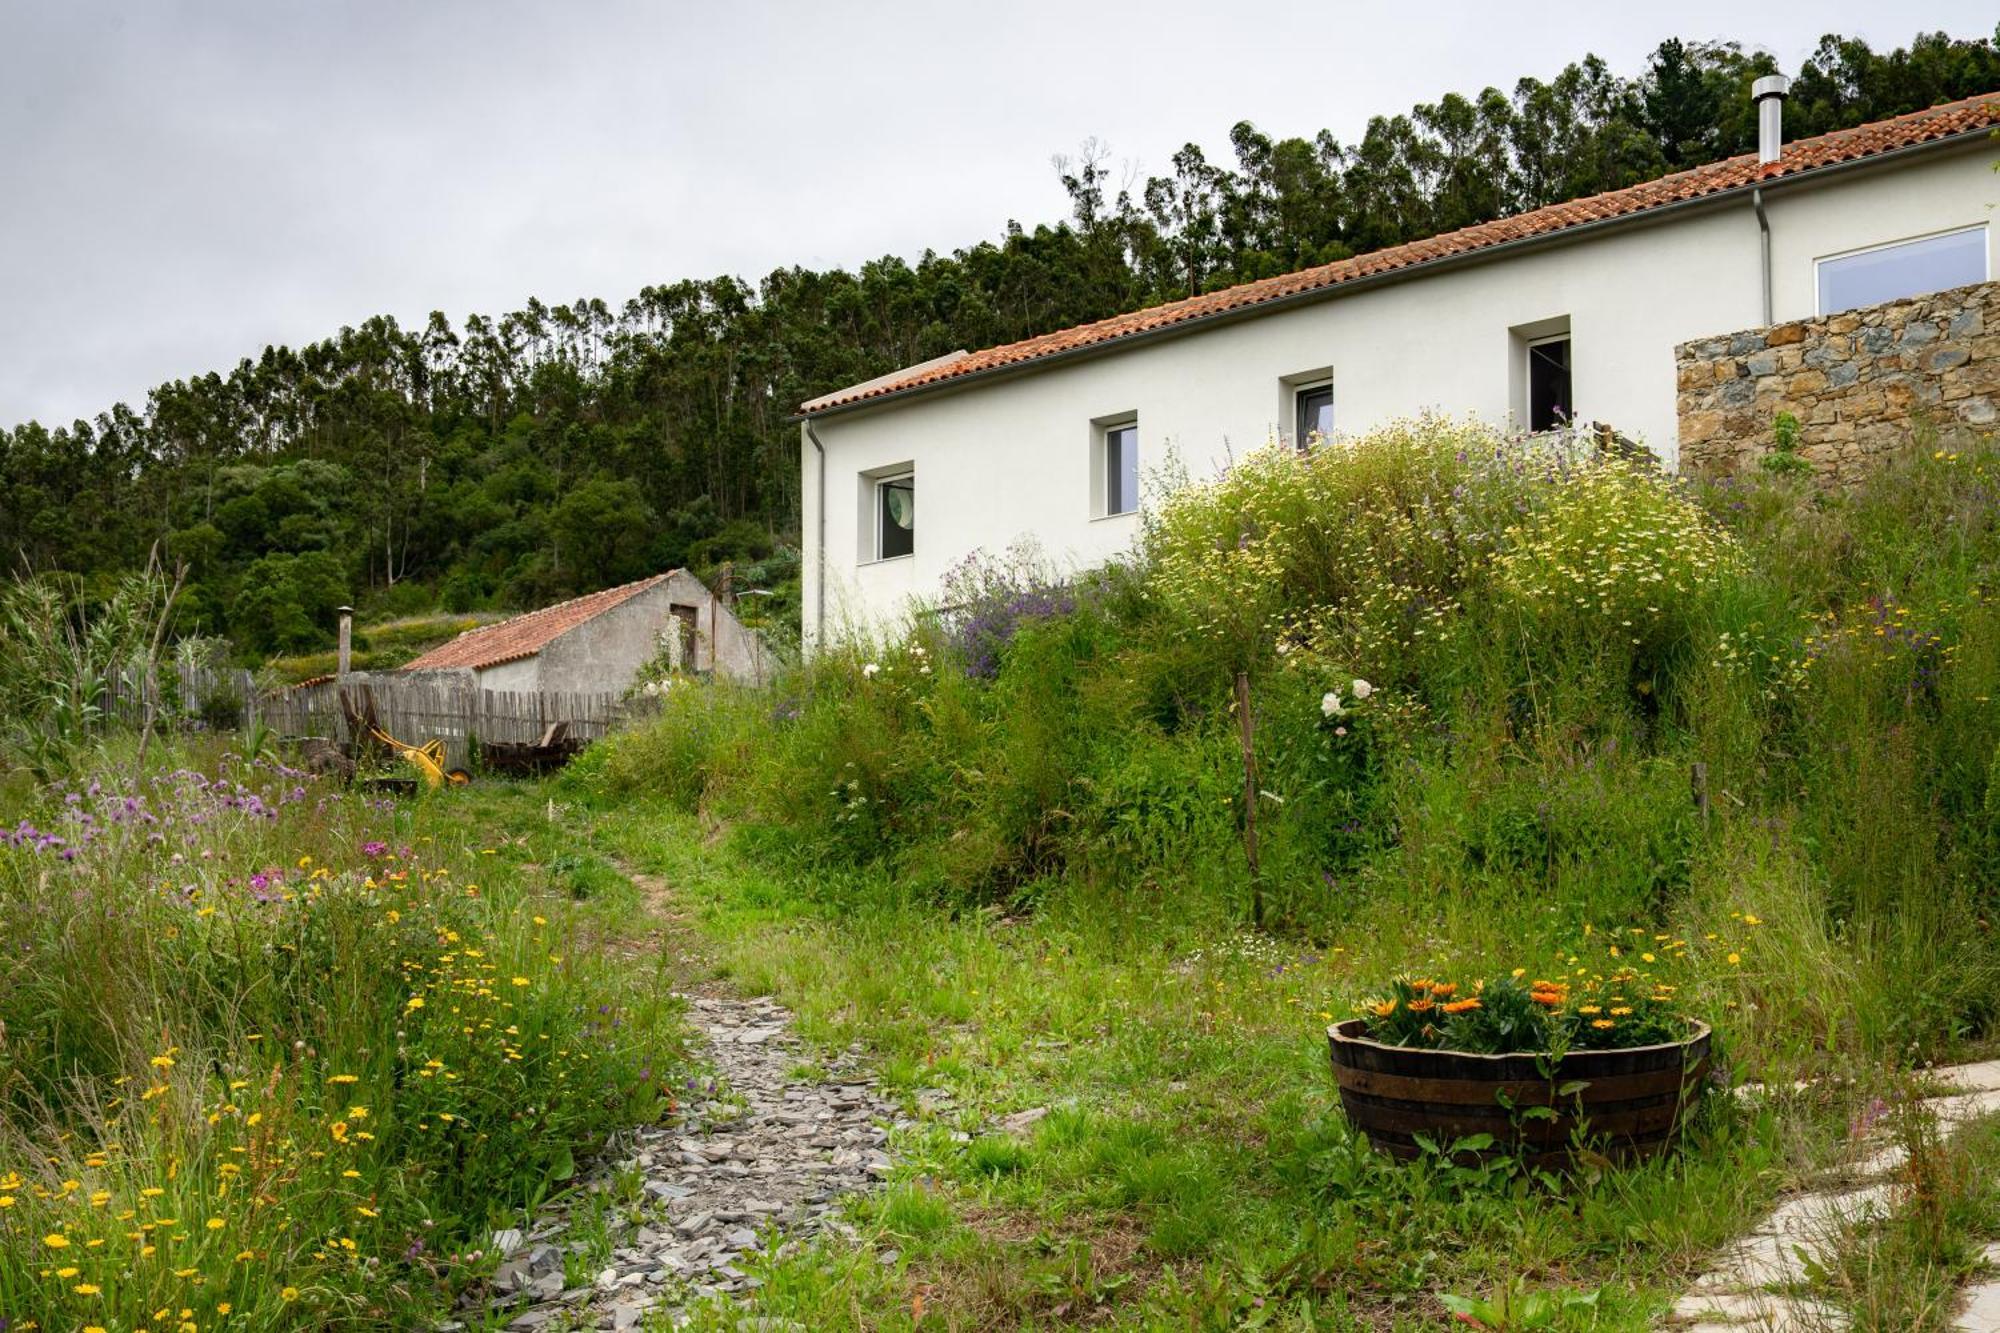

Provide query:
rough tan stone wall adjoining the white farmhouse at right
left=1674, top=282, right=2000, bottom=484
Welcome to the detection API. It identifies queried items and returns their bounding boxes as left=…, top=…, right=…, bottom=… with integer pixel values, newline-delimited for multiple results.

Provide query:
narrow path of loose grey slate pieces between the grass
left=464, top=852, right=904, bottom=1331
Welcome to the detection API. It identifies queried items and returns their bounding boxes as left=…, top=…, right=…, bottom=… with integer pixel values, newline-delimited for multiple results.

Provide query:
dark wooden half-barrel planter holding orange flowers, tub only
left=1326, top=1019, right=1710, bottom=1167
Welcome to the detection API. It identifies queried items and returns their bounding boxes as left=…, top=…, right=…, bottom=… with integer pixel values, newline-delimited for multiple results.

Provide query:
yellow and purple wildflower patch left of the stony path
left=0, top=763, right=678, bottom=1333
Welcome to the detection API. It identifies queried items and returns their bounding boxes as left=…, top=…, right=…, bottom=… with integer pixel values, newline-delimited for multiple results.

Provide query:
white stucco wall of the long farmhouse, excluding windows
left=800, top=144, right=2000, bottom=642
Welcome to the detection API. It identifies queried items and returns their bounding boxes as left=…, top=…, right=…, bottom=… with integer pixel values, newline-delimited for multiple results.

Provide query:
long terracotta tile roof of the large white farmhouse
left=800, top=92, right=2000, bottom=416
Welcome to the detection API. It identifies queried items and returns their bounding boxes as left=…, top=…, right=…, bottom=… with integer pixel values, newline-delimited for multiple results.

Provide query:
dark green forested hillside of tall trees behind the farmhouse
left=0, top=32, right=2000, bottom=654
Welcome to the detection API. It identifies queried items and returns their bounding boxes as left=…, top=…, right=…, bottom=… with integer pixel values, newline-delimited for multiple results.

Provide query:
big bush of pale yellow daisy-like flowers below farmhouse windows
left=1146, top=418, right=1742, bottom=685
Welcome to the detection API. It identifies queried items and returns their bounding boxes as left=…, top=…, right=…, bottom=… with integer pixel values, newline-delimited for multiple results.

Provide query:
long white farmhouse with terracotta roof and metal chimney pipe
left=800, top=76, right=2000, bottom=642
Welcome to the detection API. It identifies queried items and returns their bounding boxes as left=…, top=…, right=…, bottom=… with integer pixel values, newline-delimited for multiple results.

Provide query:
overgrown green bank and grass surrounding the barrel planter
left=560, top=412, right=2000, bottom=1327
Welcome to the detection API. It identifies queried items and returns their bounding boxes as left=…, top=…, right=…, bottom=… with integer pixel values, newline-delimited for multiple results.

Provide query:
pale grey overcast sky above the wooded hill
left=0, top=0, right=1994, bottom=424
